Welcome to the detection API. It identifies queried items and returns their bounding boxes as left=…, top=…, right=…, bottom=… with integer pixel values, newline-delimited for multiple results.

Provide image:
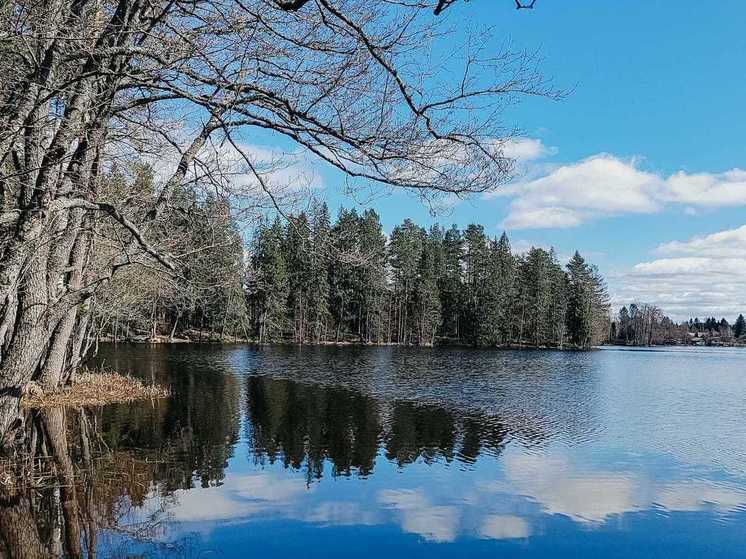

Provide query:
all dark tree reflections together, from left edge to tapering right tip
left=0, top=369, right=542, bottom=558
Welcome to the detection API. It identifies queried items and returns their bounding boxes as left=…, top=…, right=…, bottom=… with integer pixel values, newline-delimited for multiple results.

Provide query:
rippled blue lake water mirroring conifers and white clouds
left=13, top=345, right=746, bottom=559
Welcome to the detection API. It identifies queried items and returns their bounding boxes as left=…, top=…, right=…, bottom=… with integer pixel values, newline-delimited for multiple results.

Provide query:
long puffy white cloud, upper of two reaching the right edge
left=488, top=149, right=746, bottom=229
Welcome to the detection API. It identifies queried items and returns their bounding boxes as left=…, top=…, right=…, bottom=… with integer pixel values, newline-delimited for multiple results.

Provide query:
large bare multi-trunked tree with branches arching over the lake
left=0, top=0, right=554, bottom=442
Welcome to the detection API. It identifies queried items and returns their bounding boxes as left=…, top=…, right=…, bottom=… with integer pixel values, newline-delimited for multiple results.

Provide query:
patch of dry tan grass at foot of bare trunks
left=21, top=372, right=170, bottom=408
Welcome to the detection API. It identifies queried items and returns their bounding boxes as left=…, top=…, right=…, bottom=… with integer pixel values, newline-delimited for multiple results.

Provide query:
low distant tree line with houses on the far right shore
left=610, top=303, right=746, bottom=346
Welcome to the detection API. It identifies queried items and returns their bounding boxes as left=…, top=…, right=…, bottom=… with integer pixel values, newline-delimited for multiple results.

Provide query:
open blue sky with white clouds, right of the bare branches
left=241, top=0, right=746, bottom=320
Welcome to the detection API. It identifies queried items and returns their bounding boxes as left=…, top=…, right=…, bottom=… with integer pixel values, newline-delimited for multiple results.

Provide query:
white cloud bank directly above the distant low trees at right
left=609, top=225, right=746, bottom=320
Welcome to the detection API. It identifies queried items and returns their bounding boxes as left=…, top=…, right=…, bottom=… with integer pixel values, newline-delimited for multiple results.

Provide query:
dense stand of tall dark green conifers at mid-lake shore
left=246, top=204, right=609, bottom=348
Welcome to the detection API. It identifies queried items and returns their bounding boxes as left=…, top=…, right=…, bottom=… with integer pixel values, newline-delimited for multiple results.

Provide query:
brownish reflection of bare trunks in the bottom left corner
left=0, top=408, right=180, bottom=558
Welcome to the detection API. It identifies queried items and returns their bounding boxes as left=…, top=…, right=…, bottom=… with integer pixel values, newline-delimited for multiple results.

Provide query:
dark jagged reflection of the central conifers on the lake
left=246, top=376, right=520, bottom=480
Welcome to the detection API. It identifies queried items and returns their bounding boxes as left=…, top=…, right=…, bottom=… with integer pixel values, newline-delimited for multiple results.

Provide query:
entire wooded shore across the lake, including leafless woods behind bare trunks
left=97, top=200, right=609, bottom=348
